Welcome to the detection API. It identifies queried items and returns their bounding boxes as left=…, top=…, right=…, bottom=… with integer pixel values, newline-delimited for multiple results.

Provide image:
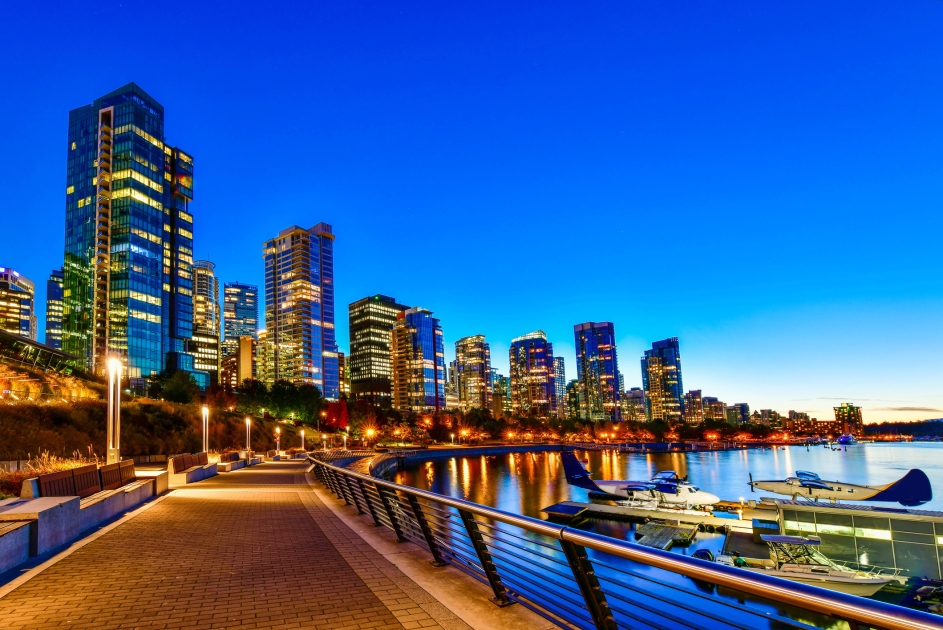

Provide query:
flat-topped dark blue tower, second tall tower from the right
left=573, top=322, right=620, bottom=422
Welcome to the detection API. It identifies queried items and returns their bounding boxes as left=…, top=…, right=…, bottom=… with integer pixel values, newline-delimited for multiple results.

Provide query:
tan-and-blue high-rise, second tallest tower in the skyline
left=262, top=223, right=340, bottom=400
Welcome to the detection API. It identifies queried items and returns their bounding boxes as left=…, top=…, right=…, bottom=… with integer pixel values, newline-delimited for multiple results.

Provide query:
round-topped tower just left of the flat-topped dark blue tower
left=508, top=330, right=557, bottom=418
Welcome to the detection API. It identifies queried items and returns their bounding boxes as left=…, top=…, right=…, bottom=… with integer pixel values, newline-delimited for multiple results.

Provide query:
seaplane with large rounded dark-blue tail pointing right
left=750, top=468, right=933, bottom=507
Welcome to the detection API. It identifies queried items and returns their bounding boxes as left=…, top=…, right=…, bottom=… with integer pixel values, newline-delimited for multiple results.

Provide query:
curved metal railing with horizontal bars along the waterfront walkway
left=308, top=457, right=943, bottom=630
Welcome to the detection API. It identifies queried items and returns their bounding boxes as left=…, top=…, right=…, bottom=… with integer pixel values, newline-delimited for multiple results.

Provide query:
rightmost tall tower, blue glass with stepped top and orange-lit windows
left=642, top=337, right=684, bottom=424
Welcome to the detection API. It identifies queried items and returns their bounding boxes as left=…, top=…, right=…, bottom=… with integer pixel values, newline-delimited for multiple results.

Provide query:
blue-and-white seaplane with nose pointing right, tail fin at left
left=562, top=451, right=720, bottom=507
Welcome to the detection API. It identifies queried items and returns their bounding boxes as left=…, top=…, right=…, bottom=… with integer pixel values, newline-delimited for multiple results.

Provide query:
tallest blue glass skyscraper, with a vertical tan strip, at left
left=62, top=83, right=209, bottom=390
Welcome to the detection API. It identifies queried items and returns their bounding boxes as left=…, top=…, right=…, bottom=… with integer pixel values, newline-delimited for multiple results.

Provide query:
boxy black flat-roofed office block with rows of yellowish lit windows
left=347, top=295, right=410, bottom=406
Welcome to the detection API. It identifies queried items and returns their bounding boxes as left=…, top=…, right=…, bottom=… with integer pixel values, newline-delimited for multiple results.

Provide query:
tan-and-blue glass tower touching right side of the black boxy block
left=391, top=307, right=446, bottom=412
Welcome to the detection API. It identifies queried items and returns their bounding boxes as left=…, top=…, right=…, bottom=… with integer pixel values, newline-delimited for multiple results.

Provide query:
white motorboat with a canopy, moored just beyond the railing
left=694, top=534, right=901, bottom=597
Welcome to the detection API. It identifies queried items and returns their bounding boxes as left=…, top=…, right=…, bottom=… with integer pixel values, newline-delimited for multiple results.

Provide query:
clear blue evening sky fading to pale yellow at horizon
left=0, top=0, right=943, bottom=421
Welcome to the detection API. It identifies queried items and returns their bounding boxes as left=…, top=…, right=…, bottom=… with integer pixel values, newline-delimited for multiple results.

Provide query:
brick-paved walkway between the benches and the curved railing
left=0, top=462, right=469, bottom=630
